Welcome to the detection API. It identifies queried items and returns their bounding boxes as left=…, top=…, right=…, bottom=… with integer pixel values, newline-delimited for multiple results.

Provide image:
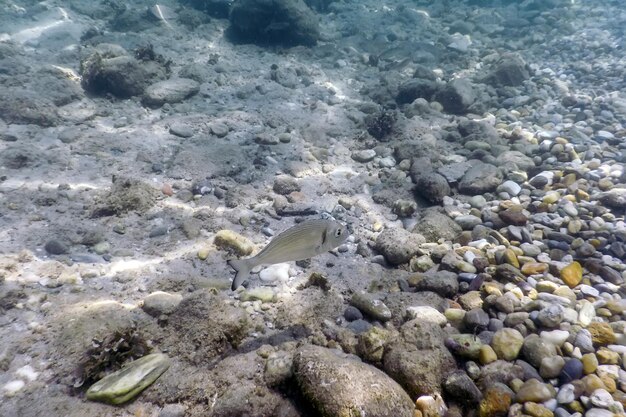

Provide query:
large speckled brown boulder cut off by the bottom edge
left=294, top=345, right=413, bottom=417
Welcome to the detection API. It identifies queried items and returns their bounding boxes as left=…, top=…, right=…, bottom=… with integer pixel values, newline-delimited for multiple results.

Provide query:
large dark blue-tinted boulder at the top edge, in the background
left=230, top=0, right=320, bottom=45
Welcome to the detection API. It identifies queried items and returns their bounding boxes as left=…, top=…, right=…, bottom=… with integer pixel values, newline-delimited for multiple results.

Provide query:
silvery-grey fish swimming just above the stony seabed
left=228, top=219, right=349, bottom=291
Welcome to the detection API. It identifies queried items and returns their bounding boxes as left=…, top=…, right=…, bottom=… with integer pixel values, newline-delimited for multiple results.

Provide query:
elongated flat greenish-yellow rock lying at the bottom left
left=87, top=353, right=170, bottom=404
